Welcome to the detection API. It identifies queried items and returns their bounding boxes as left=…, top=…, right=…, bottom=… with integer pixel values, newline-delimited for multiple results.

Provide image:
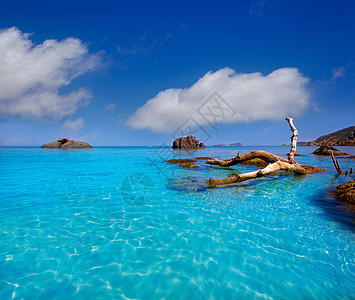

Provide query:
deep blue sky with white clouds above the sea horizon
left=0, top=0, right=355, bottom=146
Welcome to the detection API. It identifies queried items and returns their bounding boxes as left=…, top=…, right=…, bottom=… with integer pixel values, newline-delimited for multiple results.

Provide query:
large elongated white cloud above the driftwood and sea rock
left=127, top=68, right=310, bottom=132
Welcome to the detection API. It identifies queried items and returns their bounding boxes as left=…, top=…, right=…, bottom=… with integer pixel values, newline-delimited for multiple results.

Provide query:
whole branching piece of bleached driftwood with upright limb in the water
left=206, top=118, right=312, bottom=187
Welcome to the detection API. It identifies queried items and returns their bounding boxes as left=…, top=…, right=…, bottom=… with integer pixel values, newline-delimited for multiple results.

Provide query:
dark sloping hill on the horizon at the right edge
left=308, top=126, right=355, bottom=146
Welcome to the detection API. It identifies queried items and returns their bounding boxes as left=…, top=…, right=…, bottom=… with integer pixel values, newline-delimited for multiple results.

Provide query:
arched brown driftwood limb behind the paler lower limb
left=206, top=150, right=288, bottom=167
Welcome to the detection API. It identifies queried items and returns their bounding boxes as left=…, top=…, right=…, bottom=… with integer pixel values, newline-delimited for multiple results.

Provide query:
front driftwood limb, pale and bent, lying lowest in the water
left=207, top=161, right=306, bottom=187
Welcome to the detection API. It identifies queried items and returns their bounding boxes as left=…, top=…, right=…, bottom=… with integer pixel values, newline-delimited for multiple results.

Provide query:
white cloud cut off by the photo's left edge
left=0, top=27, right=101, bottom=120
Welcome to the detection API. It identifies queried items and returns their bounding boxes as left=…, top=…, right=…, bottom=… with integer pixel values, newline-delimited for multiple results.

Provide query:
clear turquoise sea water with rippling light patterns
left=0, top=147, right=355, bottom=299
